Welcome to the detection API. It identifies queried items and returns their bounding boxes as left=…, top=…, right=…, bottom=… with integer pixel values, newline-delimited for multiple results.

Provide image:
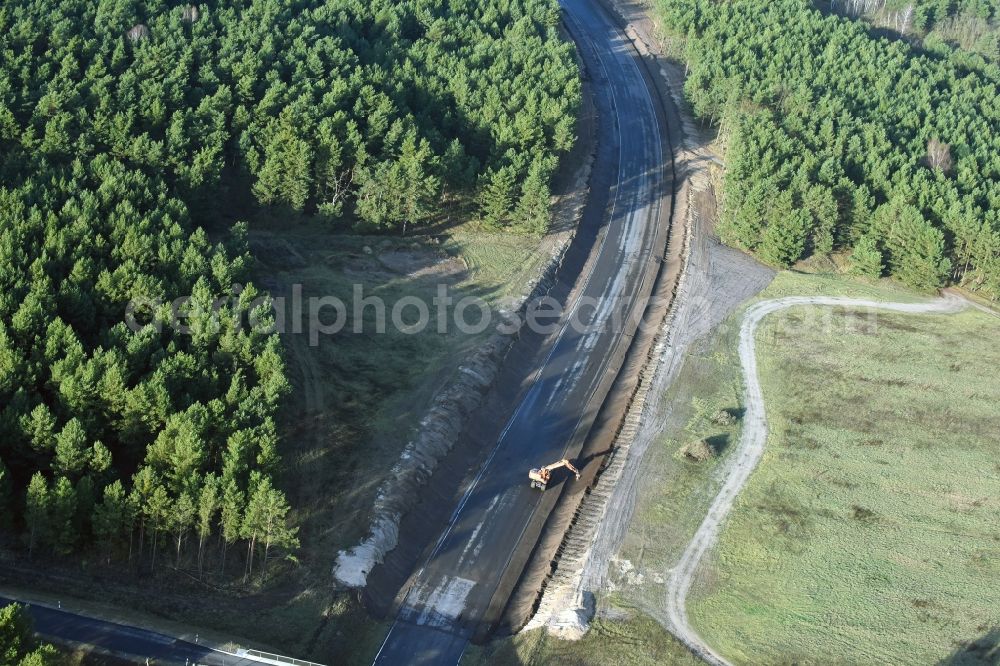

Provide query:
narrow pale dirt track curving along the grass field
left=666, top=294, right=969, bottom=664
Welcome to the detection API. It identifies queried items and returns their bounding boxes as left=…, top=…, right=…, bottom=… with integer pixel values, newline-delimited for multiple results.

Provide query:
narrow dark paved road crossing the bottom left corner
left=0, top=597, right=264, bottom=666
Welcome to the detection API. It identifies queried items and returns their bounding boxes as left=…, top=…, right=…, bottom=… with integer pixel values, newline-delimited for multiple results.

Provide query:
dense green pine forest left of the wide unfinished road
left=0, top=0, right=580, bottom=579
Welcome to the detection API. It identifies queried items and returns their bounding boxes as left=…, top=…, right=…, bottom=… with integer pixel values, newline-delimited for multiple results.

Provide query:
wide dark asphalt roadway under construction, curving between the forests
left=375, top=0, right=670, bottom=665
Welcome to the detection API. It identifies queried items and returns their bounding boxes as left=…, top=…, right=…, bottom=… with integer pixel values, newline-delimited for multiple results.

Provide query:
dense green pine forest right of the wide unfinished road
left=659, top=0, right=1000, bottom=299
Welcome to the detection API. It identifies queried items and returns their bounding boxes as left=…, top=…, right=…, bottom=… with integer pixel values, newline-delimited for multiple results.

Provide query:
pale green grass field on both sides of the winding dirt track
left=604, top=273, right=1000, bottom=664
